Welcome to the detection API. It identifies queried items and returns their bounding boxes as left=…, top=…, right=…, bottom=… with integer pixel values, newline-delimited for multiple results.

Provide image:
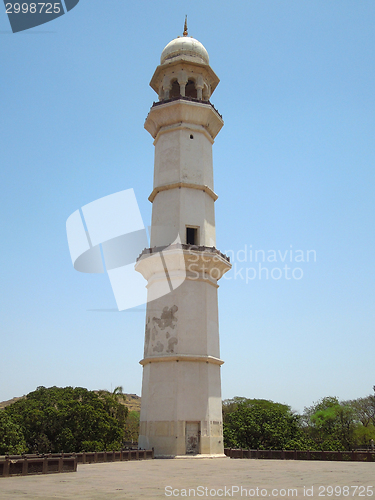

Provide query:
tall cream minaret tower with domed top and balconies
left=136, top=21, right=231, bottom=457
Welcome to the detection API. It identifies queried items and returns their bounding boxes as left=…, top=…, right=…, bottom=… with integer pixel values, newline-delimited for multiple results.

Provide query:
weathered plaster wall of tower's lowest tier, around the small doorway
left=139, top=361, right=223, bottom=455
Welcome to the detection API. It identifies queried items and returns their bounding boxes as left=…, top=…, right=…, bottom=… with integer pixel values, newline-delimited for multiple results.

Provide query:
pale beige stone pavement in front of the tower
left=0, top=458, right=375, bottom=500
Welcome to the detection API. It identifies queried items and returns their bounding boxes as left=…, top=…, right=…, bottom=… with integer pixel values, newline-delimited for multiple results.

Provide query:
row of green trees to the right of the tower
left=223, top=390, right=375, bottom=451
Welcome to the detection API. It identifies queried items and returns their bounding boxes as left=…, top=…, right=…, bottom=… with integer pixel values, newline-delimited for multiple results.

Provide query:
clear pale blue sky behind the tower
left=0, top=0, right=375, bottom=411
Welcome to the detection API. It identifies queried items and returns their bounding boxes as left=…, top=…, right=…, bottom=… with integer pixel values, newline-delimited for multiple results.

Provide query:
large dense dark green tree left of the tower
left=5, top=387, right=124, bottom=453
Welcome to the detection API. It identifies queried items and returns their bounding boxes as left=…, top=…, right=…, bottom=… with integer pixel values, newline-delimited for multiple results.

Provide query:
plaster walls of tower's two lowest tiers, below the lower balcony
left=139, top=280, right=223, bottom=455
